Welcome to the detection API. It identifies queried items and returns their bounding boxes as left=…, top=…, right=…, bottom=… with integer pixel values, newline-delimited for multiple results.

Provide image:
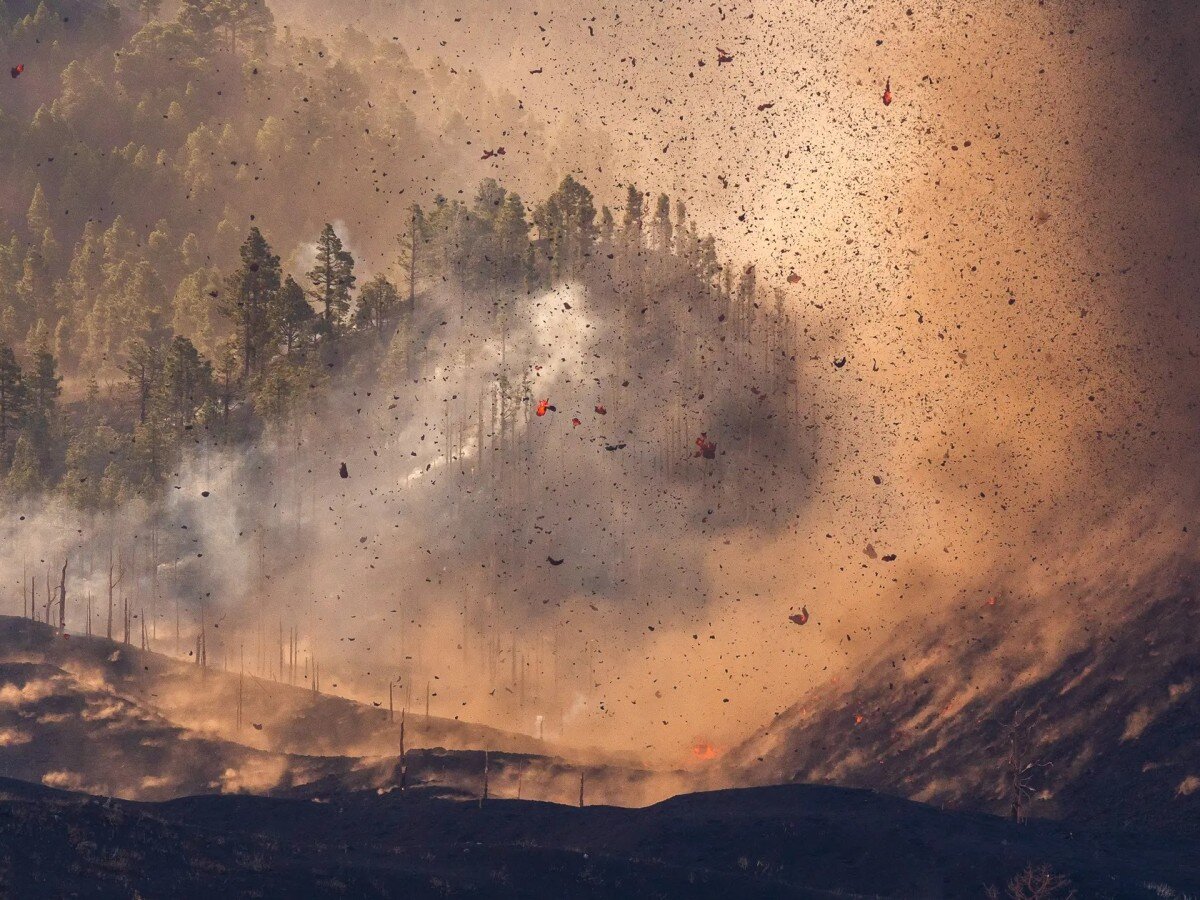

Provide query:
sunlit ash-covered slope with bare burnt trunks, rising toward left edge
left=0, top=618, right=685, bottom=804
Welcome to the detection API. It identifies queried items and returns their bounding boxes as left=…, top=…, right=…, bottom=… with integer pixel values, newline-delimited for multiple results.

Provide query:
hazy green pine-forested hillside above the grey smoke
left=0, top=0, right=784, bottom=508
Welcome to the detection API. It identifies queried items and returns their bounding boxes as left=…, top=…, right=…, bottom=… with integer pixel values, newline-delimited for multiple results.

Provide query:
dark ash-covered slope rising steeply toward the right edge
left=727, top=581, right=1200, bottom=833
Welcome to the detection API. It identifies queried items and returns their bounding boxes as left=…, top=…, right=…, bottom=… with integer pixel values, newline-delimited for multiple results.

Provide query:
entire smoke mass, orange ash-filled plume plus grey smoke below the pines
left=5, top=0, right=1200, bottom=782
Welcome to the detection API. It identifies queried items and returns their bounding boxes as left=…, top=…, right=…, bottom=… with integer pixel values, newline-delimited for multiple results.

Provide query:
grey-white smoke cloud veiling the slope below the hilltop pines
left=6, top=243, right=812, bottom=763
